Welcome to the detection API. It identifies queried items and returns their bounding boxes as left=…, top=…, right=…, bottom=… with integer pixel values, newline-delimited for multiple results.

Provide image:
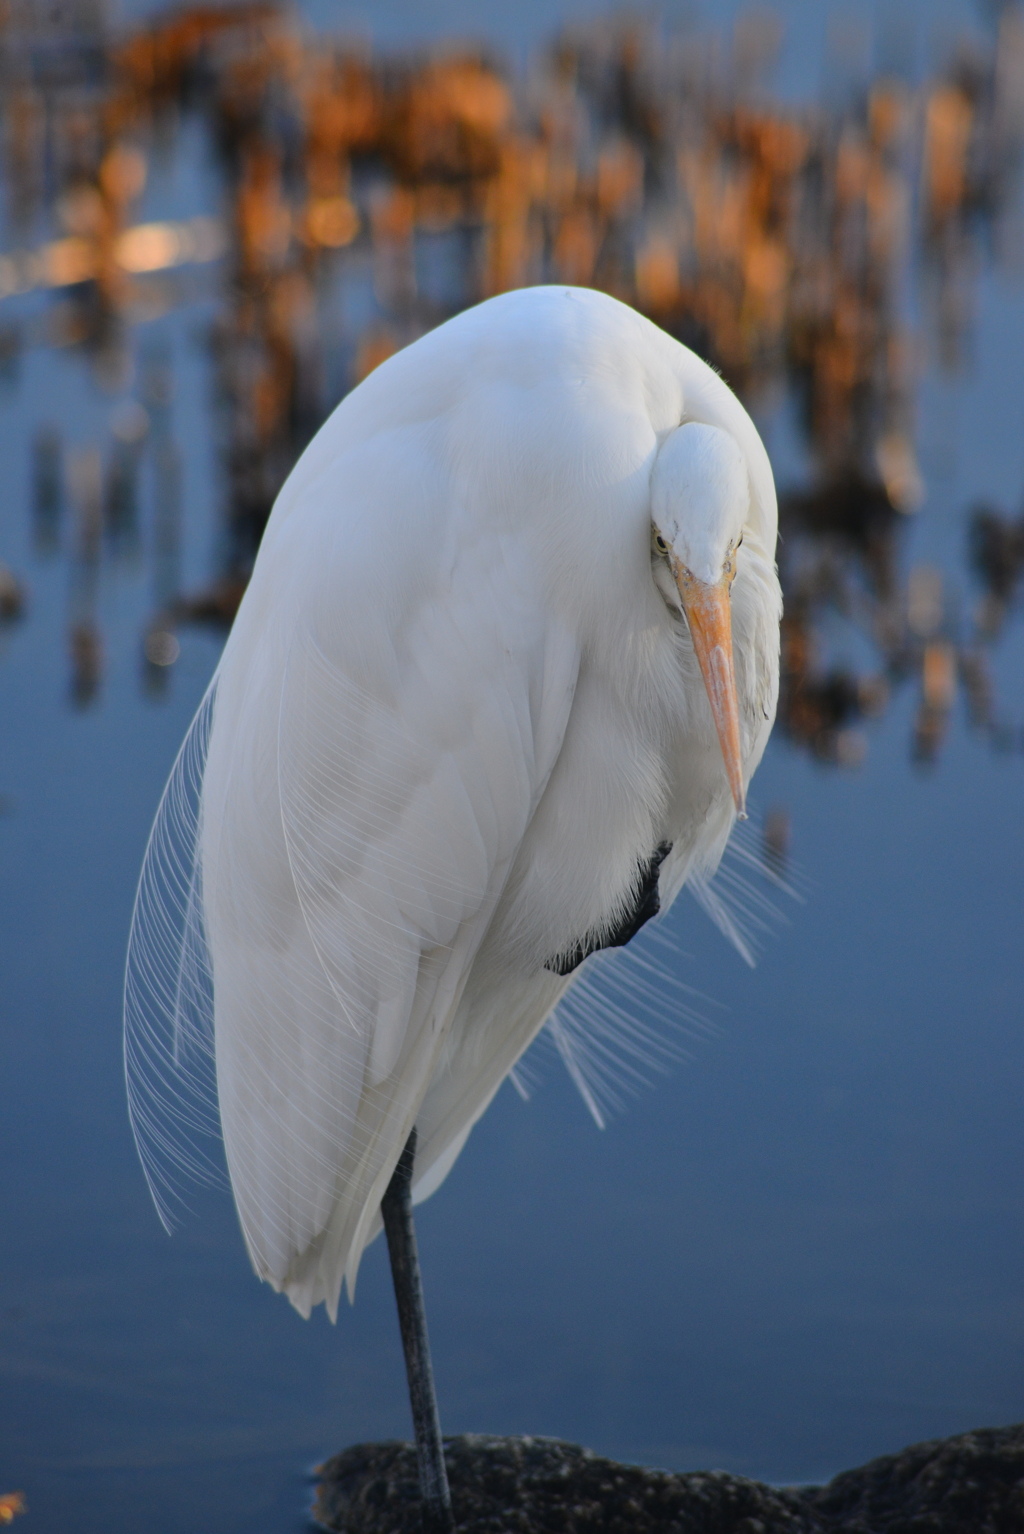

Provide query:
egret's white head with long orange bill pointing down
left=651, top=422, right=750, bottom=819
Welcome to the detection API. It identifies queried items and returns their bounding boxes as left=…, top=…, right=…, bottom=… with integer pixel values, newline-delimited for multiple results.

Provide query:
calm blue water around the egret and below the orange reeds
left=0, top=8, right=1024, bottom=1534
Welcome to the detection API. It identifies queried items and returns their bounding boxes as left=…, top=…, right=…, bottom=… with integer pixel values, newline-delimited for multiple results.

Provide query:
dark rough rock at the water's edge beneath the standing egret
left=313, top=1425, right=1024, bottom=1534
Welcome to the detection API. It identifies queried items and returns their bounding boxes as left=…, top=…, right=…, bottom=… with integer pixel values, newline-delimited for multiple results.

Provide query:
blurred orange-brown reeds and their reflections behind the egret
left=0, top=0, right=1024, bottom=767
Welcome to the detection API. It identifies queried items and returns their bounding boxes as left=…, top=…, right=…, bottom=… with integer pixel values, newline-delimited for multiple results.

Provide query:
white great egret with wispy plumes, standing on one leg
left=126, top=287, right=780, bottom=1526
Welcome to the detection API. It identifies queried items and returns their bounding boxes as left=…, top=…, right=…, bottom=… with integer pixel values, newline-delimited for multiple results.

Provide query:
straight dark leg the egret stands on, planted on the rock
left=380, top=1129, right=455, bottom=1534
